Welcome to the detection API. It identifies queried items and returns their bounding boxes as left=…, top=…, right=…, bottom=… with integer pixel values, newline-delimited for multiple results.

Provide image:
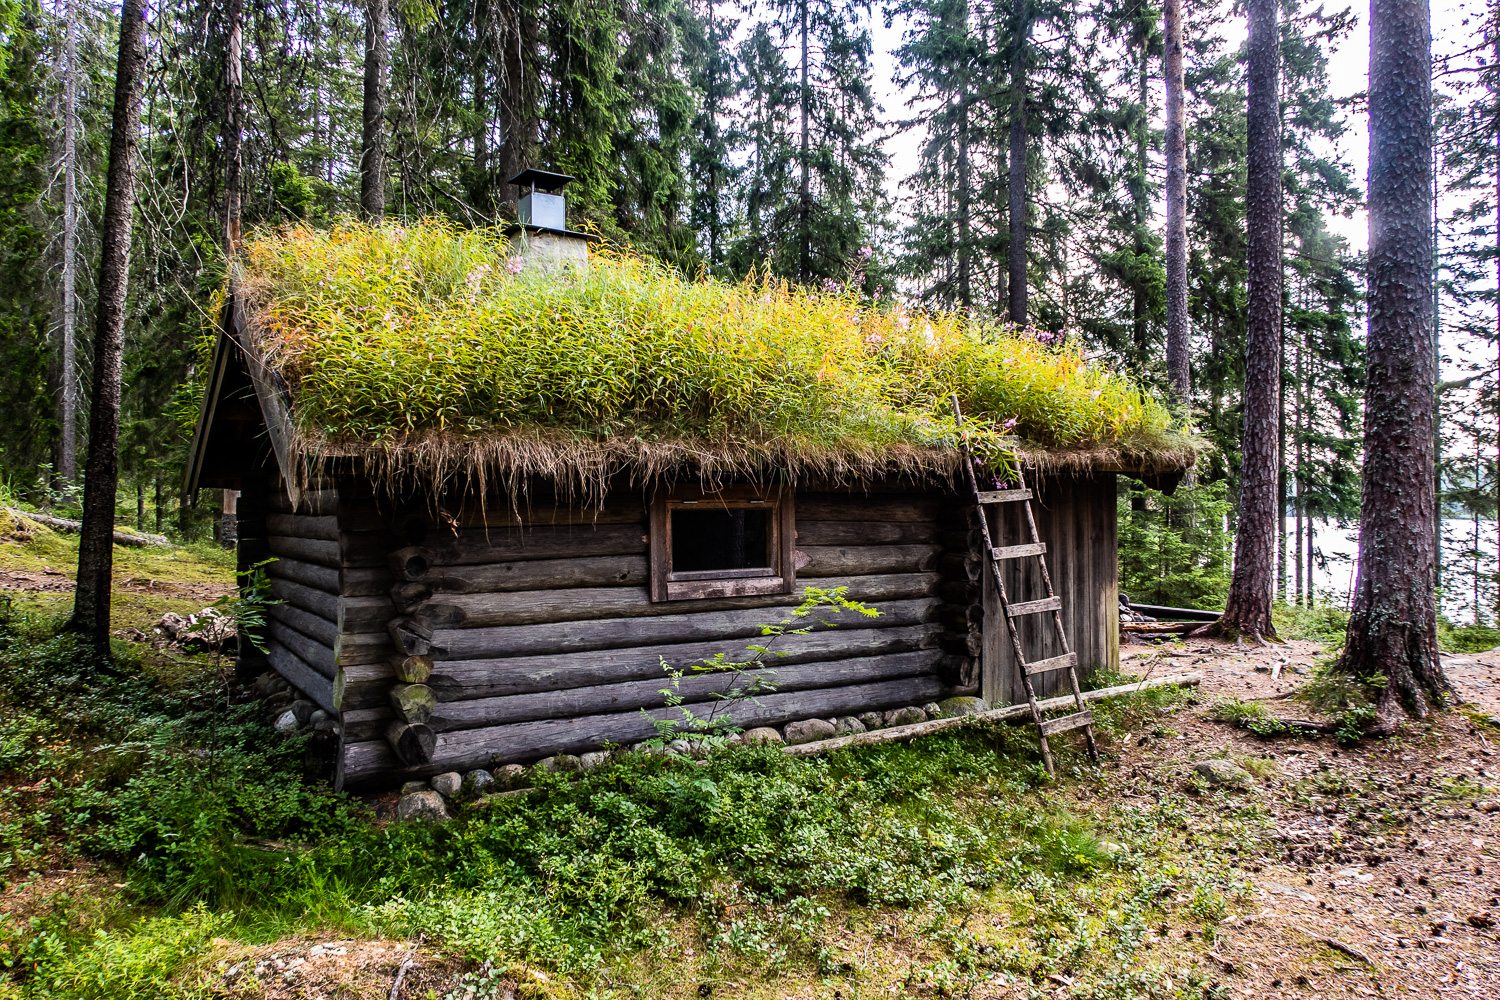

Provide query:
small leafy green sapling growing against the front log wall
left=641, top=586, right=881, bottom=747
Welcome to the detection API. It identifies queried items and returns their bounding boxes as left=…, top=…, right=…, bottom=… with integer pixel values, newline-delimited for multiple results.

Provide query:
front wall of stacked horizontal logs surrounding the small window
left=339, top=486, right=977, bottom=786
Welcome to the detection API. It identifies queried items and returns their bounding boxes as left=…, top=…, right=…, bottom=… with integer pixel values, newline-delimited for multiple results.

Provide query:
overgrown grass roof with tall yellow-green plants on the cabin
left=234, top=220, right=1193, bottom=497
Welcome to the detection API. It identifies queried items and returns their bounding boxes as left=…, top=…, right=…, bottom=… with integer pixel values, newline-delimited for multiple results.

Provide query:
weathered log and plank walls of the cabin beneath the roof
left=239, top=474, right=1118, bottom=787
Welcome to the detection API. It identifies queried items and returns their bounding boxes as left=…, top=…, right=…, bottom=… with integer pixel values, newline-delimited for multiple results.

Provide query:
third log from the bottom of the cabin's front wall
left=333, top=622, right=939, bottom=702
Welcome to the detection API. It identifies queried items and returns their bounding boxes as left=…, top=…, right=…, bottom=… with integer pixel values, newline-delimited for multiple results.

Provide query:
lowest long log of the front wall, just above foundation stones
left=344, top=675, right=947, bottom=789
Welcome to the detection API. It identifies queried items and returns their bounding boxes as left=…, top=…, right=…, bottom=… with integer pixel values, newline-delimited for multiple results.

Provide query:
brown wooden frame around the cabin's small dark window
left=650, top=486, right=797, bottom=601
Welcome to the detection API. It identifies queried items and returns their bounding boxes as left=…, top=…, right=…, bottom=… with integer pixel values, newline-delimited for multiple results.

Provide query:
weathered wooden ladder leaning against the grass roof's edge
left=953, top=393, right=1100, bottom=774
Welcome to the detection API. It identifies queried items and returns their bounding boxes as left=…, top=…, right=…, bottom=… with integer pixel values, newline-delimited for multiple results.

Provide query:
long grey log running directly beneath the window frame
left=408, top=573, right=941, bottom=628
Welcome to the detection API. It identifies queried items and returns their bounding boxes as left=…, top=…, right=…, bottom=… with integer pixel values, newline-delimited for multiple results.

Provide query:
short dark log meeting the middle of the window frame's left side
left=390, top=520, right=647, bottom=580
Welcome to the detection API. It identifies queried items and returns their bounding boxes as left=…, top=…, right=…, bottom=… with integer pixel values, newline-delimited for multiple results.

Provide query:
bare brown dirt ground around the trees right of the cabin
left=1116, top=640, right=1500, bottom=997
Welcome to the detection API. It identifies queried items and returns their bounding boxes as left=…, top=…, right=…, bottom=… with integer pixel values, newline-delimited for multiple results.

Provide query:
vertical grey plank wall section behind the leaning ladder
left=981, top=472, right=1119, bottom=705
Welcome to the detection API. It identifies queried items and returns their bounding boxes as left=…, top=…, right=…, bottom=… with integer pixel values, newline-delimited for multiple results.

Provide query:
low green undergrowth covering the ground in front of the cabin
left=0, top=593, right=1254, bottom=997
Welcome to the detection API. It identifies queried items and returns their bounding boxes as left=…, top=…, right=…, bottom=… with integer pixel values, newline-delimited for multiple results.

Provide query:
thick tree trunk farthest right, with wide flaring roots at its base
left=1340, top=0, right=1452, bottom=732
